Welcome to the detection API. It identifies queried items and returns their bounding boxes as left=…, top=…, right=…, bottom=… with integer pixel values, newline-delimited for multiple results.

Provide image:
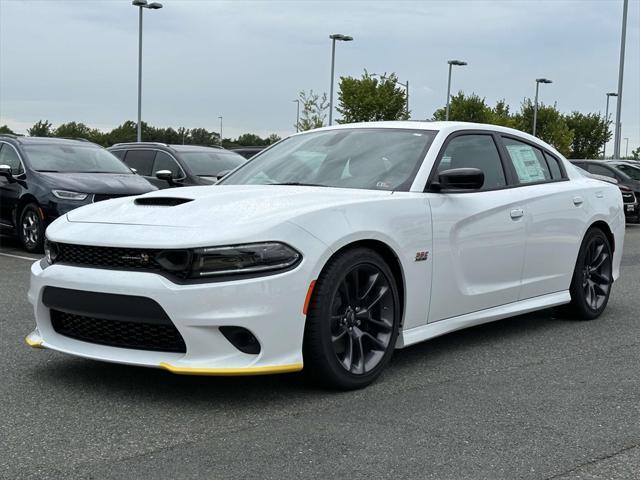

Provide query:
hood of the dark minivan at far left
left=39, top=172, right=157, bottom=195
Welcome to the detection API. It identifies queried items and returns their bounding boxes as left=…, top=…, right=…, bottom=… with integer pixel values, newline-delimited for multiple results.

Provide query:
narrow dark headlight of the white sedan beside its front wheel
left=190, top=242, right=302, bottom=278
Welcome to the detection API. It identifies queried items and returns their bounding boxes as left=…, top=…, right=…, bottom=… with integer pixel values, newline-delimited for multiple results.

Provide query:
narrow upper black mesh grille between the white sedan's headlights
left=55, top=243, right=164, bottom=271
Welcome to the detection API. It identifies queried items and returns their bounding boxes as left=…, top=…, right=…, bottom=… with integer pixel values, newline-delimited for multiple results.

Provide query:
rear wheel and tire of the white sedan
left=569, top=228, right=613, bottom=320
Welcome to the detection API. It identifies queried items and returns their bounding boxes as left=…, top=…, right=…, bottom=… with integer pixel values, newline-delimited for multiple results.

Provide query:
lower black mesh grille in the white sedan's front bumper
left=51, top=310, right=187, bottom=353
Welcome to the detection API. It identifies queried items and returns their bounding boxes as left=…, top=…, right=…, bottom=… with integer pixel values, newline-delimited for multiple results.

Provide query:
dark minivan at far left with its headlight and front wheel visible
left=0, top=134, right=157, bottom=252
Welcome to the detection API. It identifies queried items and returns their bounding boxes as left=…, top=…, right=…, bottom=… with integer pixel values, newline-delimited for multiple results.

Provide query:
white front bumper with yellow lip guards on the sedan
left=25, top=259, right=313, bottom=375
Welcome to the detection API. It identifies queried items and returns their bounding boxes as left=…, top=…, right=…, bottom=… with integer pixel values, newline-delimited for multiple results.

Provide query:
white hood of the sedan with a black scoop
left=67, top=185, right=392, bottom=229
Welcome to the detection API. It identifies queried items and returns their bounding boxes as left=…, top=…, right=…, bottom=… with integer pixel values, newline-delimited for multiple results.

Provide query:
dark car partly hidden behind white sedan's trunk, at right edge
left=570, top=160, right=640, bottom=222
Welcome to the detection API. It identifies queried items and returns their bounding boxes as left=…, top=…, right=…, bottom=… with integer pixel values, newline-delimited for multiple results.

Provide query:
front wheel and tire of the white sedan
left=303, top=248, right=400, bottom=390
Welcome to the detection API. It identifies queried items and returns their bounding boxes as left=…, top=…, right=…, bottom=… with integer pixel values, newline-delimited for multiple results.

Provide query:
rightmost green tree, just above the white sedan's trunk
left=565, top=111, right=612, bottom=158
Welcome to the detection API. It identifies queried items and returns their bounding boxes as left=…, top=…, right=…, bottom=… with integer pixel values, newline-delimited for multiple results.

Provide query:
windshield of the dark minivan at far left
left=24, top=144, right=133, bottom=175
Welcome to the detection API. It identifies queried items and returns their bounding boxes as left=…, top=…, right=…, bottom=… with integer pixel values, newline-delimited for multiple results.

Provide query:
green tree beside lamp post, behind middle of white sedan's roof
left=337, top=70, right=409, bottom=123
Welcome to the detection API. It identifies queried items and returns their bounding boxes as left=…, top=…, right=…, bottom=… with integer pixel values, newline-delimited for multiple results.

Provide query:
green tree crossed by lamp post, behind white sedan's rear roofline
left=514, top=98, right=573, bottom=157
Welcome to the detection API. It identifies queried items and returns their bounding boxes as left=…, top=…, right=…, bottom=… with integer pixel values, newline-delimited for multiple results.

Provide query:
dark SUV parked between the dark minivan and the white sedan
left=108, top=142, right=246, bottom=188
